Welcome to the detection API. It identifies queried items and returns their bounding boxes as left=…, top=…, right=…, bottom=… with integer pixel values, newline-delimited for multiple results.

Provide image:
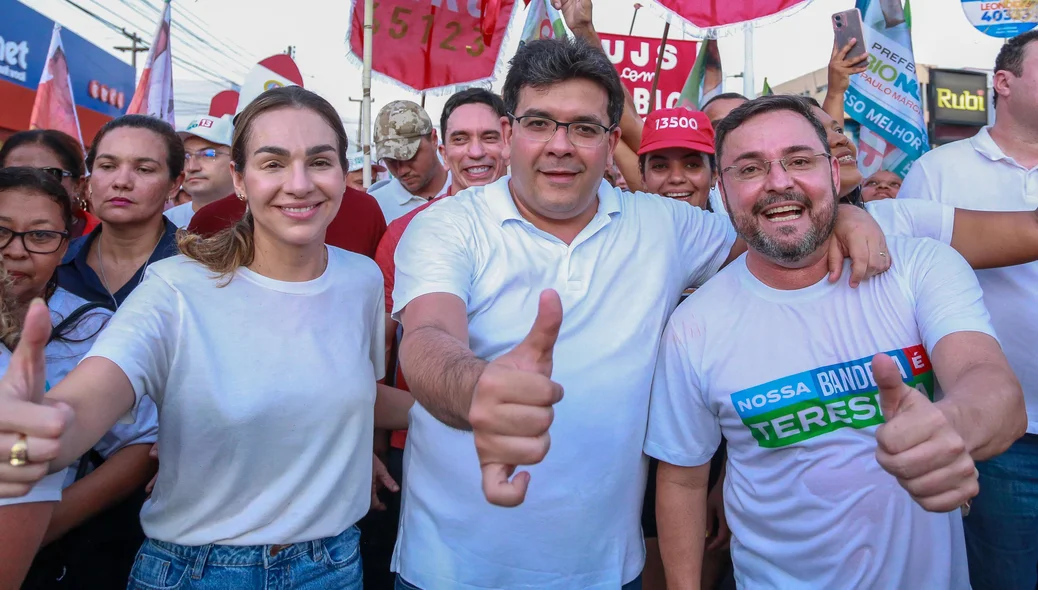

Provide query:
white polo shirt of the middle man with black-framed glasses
left=392, top=177, right=735, bottom=590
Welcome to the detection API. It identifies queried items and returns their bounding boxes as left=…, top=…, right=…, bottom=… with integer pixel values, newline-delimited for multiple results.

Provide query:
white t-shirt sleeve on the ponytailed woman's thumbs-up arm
left=86, top=269, right=181, bottom=424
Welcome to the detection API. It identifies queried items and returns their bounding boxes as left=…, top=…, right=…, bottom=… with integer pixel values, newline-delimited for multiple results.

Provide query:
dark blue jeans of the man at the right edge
left=963, top=434, right=1038, bottom=590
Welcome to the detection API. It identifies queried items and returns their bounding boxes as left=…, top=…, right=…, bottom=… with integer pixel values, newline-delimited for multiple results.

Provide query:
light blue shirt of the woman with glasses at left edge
left=0, top=288, right=159, bottom=506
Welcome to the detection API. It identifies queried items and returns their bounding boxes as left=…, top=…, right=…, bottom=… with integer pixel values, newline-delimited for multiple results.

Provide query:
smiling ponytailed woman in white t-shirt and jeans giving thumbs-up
left=0, top=87, right=411, bottom=590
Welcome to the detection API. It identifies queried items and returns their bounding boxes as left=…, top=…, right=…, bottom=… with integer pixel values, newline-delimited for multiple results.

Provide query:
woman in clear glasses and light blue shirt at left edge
left=0, top=167, right=158, bottom=588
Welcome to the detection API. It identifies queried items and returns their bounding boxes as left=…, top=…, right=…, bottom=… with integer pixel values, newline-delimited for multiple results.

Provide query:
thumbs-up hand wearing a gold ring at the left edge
left=0, top=299, right=71, bottom=498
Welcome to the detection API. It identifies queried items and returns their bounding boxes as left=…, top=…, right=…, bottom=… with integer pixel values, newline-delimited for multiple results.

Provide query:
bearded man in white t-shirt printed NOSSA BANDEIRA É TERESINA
left=645, top=97, right=1027, bottom=590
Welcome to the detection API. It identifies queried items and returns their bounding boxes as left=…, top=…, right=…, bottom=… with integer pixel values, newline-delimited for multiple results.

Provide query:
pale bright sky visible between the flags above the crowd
left=21, top=0, right=1003, bottom=136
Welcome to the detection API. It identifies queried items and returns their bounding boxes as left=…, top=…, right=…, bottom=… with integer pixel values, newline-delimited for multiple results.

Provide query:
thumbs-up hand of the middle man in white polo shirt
left=468, top=290, right=563, bottom=506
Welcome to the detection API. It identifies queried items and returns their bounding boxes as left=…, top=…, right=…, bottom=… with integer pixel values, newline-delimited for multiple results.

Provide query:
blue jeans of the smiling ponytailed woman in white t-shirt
left=127, top=527, right=363, bottom=590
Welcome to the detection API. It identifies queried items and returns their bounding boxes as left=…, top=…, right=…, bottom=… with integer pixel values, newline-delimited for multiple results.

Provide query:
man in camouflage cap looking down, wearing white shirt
left=367, top=101, right=450, bottom=224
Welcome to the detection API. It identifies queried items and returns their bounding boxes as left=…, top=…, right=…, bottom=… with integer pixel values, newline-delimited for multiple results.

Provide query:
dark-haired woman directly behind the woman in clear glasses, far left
left=0, top=129, right=100, bottom=239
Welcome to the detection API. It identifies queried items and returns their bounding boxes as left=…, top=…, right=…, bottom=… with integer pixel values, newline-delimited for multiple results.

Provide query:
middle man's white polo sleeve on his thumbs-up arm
left=392, top=203, right=475, bottom=321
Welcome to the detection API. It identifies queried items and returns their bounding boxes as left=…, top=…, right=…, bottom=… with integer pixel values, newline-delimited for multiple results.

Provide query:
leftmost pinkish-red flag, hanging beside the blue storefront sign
left=29, top=23, right=83, bottom=145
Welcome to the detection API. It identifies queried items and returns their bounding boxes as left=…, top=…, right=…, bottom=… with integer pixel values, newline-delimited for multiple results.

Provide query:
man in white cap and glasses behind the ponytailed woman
left=166, top=115, right=235, bottom=227
